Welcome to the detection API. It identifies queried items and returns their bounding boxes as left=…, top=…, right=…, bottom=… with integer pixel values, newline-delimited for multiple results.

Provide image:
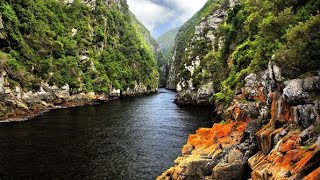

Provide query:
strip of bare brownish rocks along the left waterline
left=0, top=71, right=157, bottom=122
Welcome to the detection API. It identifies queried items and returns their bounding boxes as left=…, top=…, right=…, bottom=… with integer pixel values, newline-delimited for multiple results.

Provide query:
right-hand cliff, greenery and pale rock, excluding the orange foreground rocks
left=167, top=0, right=319, bottom=104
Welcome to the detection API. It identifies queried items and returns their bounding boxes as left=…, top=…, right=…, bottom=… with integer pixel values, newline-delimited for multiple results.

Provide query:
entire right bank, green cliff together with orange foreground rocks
left=158, top=0, right=320, bottom=180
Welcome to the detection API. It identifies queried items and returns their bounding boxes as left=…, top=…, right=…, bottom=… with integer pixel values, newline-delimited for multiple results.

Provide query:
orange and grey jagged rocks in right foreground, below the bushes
left=157, top=62, right=320, bottom=180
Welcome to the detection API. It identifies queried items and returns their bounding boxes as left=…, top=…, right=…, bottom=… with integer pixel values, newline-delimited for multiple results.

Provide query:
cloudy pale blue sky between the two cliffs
left=127, top=0, right=207, bottom=38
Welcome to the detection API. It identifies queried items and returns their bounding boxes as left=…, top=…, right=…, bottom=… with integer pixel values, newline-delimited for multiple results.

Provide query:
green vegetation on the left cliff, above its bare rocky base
left=0, top=0, right=158, bottom=93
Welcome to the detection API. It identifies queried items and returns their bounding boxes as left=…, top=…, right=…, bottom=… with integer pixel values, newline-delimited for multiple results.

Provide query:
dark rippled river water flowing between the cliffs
left=0, top=89, right=212, bottom=179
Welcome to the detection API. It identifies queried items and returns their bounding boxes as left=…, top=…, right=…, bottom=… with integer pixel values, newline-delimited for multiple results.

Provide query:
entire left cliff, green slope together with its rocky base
left=0, top=0, right=159, bottom=119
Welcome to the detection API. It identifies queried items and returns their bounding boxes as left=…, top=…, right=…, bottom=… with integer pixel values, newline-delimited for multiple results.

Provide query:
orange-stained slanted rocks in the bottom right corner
left=249, top=129, right=320, bottom=179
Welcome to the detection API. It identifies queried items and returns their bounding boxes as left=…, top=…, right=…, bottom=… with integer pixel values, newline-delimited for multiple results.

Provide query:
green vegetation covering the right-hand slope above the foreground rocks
left=175, top=0, right=320, bottom=105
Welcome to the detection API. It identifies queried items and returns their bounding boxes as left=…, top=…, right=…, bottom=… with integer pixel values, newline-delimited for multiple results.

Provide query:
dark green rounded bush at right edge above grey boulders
left=276, top=15, right=320, bottom=78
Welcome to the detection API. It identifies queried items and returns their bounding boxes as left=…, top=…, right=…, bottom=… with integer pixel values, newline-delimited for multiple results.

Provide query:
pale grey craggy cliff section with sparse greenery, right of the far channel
left=167, top=0, right=238, bottom=104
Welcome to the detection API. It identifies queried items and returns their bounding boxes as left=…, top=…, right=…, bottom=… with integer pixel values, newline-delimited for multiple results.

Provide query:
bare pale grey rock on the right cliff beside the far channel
left=169, top=6, right=230, bottom=105
